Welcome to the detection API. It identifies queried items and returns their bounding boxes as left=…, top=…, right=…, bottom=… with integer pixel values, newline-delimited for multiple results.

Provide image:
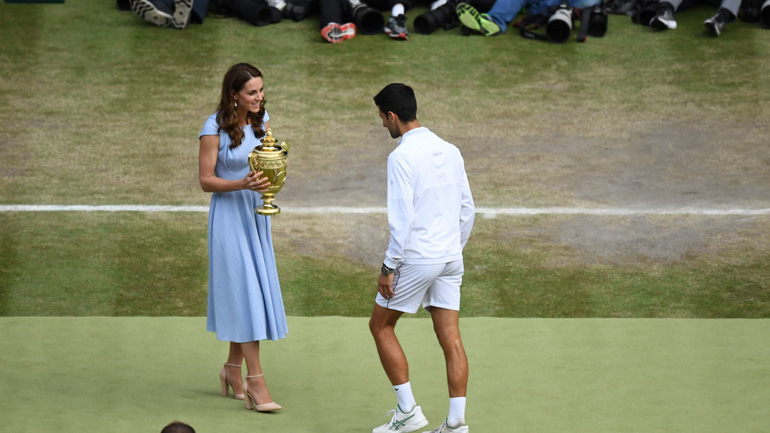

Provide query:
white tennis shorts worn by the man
left=375, top=260, right=464, bottom=314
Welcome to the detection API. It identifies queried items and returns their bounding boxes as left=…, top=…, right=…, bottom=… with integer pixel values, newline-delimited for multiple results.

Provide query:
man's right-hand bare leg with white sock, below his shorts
left=430, top=307, right=468, bottom=429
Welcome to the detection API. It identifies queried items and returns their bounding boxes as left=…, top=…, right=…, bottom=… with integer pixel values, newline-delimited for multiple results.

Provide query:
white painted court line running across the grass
left=0, top=205, right=770, bottom=218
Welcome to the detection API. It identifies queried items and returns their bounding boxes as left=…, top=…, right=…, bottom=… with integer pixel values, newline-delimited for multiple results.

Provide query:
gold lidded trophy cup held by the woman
left=249, top=129, right=289, bottom=215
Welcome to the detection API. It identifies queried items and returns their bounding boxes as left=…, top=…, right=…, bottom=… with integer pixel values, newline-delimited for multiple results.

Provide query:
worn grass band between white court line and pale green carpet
left=0, top=212, right=770, bottom=318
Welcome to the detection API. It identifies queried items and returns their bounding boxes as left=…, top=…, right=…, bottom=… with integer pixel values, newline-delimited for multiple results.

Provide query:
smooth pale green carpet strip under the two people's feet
left=0, top=317, right=770, bottom=433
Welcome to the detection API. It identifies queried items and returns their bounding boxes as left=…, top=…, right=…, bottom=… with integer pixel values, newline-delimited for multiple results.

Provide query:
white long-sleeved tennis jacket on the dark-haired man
left=384, top=127, right=476, bottom=269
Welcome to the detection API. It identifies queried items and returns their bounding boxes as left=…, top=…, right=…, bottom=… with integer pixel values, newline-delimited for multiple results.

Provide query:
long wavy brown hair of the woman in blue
left=217, top=63, right=265, bottom=149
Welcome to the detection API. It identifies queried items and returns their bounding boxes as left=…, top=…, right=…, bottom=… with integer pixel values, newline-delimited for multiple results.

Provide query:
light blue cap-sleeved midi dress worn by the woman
left=199, top=113, right=288, bottom=343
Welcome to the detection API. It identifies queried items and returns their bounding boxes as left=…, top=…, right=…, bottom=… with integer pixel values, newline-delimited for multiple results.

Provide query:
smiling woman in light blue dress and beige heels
left=199, top=63, right=288, bottom=412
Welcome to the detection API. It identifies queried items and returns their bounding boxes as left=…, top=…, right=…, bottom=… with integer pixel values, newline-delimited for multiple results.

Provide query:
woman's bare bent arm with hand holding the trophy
left=198, top=135, right=270, bottom=192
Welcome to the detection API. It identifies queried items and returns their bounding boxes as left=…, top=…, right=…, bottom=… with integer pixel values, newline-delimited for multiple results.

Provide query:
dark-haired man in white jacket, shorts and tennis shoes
left=369, top=83, right=475, bottom=433
